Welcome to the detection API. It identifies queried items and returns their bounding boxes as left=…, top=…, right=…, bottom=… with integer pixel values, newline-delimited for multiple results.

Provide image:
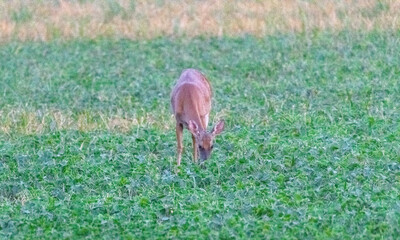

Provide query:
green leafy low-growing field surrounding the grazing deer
left=0, top=32, right=400, bottom=239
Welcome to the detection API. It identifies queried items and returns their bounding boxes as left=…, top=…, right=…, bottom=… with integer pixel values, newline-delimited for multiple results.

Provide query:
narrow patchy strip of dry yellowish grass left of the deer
left=0, top=108, right=173, bottom=135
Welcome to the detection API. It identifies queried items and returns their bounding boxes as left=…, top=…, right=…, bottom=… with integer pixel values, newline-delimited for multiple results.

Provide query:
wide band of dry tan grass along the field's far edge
left=0, top=0, right=400, bottom=42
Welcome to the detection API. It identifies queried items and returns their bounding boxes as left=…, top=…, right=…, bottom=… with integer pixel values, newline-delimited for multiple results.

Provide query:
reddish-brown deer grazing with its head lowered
left=171, top=69, right=224, bottom=166
